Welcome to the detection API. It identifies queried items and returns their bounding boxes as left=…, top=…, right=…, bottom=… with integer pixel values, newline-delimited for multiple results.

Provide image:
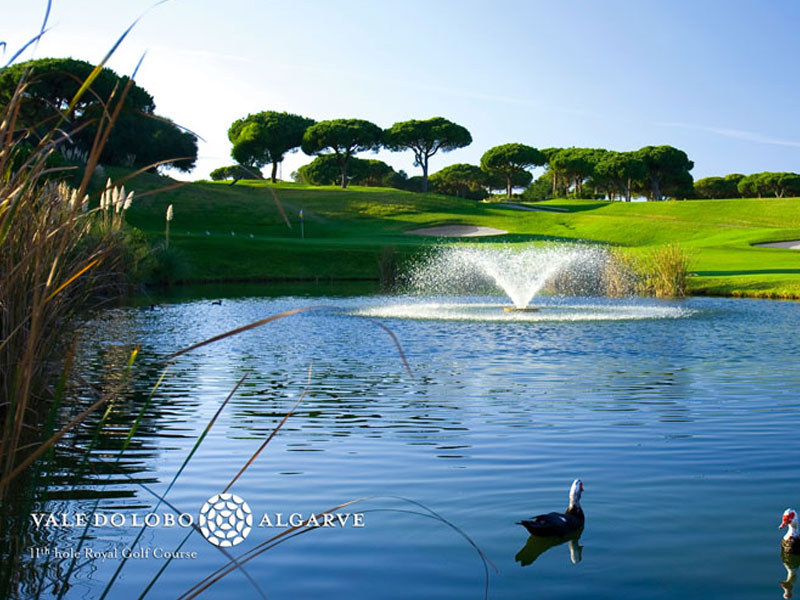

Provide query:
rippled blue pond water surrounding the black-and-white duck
left=17, top=297, right=800, bottom=599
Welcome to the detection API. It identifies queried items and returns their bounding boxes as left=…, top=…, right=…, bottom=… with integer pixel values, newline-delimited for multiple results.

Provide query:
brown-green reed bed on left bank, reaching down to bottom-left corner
left=0, top=50, right=150, bottom=594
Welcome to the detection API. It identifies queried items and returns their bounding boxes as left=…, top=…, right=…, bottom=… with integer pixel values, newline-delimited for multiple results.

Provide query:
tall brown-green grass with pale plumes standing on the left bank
left=0, top=37, right=148, bottom=497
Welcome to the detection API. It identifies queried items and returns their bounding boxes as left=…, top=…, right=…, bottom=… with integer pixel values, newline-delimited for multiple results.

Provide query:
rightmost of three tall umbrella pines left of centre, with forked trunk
left=383, top=117, right=472, bottom=192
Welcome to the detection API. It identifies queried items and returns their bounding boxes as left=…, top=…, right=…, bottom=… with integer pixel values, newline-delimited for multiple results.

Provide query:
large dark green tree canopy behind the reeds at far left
left=0, top=58, right=197, bottom=171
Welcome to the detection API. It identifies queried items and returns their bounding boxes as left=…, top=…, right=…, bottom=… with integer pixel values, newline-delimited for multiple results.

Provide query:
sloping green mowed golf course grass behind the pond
left=122, top=170, right=800, bottom=298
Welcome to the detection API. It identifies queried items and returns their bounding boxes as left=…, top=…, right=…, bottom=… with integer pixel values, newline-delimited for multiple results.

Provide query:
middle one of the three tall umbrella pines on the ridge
left=301, top=119, right=383, bottom=188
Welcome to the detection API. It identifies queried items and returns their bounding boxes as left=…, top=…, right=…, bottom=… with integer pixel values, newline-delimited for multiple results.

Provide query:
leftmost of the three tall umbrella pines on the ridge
left=228, top=110, right=314, bottom=183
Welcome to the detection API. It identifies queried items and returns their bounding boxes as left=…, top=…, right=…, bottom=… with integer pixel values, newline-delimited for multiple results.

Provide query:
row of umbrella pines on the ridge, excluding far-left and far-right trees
left=217, top=111, right=694, bottom=201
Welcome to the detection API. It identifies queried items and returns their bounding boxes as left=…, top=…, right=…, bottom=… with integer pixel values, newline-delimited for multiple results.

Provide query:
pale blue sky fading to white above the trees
left=0, top=0, right=800, bottom=179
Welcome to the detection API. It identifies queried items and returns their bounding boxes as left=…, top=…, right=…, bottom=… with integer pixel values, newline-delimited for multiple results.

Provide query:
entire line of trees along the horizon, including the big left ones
left=6, top=58, right=800, bottom=201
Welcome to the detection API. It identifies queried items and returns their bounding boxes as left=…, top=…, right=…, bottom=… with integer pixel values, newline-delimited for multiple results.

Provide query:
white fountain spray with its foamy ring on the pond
left=353, top=244, right=693, bottom=322
